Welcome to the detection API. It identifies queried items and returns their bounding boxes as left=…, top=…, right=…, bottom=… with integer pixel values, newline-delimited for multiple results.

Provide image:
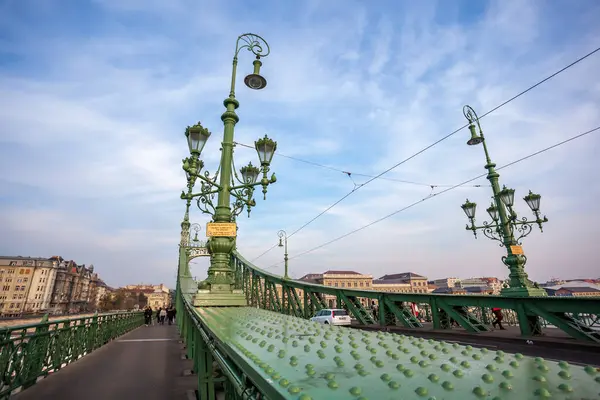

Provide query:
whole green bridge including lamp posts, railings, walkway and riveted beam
left=0, top=34, right=600, bottom=400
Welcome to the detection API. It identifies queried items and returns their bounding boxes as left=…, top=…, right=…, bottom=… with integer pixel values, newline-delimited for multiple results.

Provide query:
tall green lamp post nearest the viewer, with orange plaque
left=181, top=33, right=277, bottom=306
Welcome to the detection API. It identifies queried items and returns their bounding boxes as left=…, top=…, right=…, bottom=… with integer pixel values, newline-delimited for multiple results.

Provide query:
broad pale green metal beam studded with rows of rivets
left=197, top=307, right=600, bottom=400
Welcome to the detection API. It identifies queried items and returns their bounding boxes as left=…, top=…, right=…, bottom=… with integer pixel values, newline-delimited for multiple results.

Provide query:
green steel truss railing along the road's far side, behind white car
left=232, top=252, right=600, bottom=343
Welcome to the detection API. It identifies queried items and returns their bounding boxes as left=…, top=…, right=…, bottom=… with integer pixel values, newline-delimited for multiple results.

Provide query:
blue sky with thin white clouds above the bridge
left=0, top=0, right=600, bottom=286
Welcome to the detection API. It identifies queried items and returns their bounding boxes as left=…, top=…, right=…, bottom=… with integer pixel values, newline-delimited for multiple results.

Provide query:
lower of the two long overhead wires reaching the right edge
left=265, top=126, right=600, bottom=269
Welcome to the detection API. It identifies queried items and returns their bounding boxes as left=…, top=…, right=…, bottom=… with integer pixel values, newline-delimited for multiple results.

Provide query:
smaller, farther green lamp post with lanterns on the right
left=461, top=106, right=548, bottom=297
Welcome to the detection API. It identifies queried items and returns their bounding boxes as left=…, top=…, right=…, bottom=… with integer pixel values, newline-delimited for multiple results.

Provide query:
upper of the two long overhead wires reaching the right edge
left=248, top=47, right=600, bottom=261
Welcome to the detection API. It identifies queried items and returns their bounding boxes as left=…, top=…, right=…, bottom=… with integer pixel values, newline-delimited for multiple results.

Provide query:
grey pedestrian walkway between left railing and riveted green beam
left=11, top=325, right=189, bottom=400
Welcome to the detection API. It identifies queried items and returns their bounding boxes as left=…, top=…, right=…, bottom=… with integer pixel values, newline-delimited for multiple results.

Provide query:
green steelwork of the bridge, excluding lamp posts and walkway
left=0, top=238, right=600, bottom=400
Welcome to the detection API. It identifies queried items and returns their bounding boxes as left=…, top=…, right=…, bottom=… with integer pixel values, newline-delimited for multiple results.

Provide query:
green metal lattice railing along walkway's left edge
left=0, top=312, right=144, bottom=399
